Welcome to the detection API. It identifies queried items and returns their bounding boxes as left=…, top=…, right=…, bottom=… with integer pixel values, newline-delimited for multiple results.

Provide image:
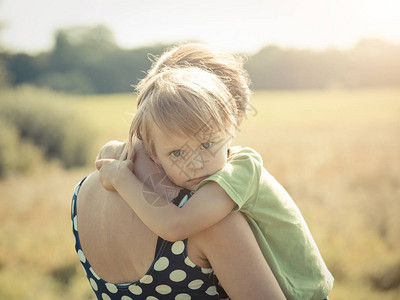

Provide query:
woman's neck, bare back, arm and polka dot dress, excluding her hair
left=72, top=142, right=285, bottom=300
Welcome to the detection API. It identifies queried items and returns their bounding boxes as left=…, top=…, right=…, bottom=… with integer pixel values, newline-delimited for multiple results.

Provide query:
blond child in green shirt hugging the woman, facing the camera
left=97, top=68, right=333, bottom=299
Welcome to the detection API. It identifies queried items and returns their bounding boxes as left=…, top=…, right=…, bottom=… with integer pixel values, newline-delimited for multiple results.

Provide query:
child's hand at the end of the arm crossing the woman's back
left=96, top=159, right=133, bottom=192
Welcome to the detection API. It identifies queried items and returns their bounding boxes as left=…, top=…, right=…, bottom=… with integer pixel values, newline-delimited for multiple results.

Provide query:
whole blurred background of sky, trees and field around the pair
left=0, top=0, right=400, bottom=299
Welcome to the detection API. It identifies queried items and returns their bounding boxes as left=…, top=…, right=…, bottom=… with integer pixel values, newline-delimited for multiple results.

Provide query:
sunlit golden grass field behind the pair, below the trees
left=0, top=88, right=400, bottom=300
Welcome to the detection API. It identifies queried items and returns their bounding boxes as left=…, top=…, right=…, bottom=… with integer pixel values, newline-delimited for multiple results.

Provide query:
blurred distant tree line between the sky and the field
left=0, top=25, right=400, bottom=94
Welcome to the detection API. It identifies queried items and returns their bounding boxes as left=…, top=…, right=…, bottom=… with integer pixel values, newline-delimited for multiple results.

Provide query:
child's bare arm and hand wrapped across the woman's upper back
left=96, top=160, right=236, bottom=241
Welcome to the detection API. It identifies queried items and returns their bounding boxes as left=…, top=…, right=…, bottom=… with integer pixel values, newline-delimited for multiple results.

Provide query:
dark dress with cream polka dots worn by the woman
left=71, top=179, right=226, bottom=300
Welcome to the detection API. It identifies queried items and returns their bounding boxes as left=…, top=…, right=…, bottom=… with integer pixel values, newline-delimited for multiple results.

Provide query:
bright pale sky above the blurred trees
left=0, top=0, right=400, bottom=54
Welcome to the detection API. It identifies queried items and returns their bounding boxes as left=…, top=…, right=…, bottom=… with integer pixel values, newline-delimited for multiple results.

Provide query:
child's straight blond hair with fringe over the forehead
left=123, top=67, right=237, bottom=159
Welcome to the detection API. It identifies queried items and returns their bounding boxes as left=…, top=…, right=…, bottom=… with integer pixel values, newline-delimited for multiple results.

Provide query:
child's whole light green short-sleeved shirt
left=197, top=147, right=333, bottom=300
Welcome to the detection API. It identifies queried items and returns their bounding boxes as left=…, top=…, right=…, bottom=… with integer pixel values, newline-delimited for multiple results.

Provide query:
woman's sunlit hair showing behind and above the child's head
left=137, top=43, right=251, bottom=124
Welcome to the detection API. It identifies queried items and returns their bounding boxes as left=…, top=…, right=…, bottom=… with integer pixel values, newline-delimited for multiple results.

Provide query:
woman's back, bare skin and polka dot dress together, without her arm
left=71, top=173, right=225, bottom=300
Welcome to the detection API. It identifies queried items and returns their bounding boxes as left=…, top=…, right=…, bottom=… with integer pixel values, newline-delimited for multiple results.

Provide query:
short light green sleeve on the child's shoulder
left=196, top=147, right=263, bottom=211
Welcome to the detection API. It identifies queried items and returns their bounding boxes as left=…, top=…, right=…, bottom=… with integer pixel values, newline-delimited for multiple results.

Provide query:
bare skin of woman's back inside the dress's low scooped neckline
left=76, top=172, right=157, bottom=283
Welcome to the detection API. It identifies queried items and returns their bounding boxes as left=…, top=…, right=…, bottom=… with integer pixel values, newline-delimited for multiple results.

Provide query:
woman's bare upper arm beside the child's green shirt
left=198, top=212, right=286, bottom=300
